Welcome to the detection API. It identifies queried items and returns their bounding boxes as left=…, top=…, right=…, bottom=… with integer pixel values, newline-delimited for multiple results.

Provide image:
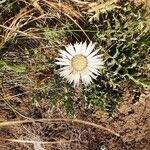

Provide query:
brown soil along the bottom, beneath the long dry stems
left=0, top=88, right=150, bottom=150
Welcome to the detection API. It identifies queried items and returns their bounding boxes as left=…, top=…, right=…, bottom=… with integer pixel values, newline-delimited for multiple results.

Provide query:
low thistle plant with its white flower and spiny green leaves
left=31, top=1, right=150, bottom=115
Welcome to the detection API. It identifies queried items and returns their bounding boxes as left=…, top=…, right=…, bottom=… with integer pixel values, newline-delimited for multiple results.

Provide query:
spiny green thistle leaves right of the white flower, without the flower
left=85, top=1, right=150, bottom=115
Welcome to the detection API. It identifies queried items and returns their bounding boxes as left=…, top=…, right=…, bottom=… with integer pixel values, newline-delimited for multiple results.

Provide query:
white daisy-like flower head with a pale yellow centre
left=56, top=42, right=104, bottom=86
